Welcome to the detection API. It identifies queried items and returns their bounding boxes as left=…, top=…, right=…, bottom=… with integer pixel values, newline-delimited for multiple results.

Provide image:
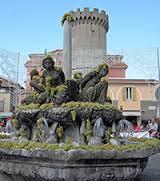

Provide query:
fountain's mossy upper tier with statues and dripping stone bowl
left=17, top=55, right=121, bottom=145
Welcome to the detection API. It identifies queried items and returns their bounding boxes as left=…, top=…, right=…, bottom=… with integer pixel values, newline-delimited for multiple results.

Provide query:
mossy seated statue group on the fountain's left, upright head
left=22, top=55, right=69, bottom=105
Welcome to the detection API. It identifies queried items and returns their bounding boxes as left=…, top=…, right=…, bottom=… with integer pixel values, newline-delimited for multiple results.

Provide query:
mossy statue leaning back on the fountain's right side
left=79, top=64, right=108, bottom=103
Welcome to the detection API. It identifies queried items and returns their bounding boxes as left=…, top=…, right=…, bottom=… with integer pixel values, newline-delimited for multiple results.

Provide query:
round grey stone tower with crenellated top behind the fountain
left=70, top=8, right=109, bottom=73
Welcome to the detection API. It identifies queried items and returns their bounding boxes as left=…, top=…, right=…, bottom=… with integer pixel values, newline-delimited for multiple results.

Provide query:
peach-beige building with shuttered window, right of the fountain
left=108, top=78, right=158, bottom=121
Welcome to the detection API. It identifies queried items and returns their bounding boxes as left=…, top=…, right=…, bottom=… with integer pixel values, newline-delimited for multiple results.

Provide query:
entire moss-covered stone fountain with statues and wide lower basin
left=0, top=55, right=159, bottom=181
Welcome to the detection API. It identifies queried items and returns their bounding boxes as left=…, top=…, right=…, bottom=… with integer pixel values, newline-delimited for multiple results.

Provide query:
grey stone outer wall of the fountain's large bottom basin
left=0, top=148, right=160, bottom=181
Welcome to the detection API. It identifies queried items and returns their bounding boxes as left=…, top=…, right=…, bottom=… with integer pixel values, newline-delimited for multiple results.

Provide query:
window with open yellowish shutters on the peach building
left=122, top=87, right=136, bottom=101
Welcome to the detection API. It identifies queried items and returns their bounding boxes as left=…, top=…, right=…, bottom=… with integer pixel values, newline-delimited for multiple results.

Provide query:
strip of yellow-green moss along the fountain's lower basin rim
left=0, top=138, right=160, bottom=151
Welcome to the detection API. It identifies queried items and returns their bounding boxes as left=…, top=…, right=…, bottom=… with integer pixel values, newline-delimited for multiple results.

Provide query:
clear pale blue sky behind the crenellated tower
left=0, top=0, right=160, bottom=82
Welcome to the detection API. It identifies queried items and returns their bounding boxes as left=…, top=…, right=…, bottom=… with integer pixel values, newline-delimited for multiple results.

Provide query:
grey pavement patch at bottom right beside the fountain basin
left=135, top=153, right=160, bottom=181
